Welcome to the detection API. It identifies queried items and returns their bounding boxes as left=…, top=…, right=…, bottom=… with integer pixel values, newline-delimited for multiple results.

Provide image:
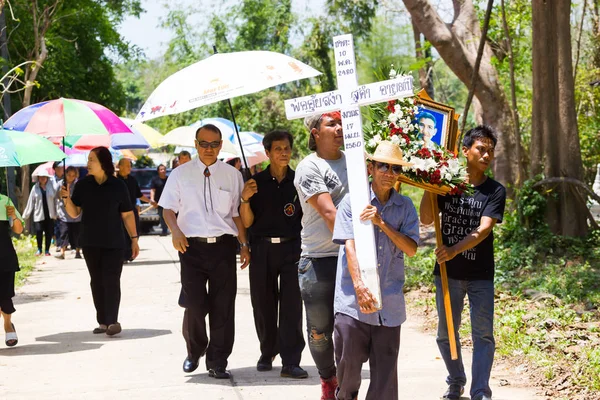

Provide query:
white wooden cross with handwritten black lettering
left=285, top=34, right=414, bottom=308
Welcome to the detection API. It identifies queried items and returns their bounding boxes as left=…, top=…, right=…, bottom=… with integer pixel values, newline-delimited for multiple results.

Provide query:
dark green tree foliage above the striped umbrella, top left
left=7, top=0, right=142, bottom=112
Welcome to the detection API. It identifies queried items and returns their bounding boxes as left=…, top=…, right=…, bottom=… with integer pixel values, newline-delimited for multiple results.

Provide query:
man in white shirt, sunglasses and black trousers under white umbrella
left=159, top=125, right=250, bottom=379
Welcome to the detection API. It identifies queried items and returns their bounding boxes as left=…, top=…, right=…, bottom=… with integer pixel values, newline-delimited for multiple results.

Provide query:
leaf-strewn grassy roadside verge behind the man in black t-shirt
left=405, top=231, right=600, bottom=399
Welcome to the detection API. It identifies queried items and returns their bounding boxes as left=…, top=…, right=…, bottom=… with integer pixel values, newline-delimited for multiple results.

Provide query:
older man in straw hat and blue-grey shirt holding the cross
left=333, top=141, right=419, bottom=400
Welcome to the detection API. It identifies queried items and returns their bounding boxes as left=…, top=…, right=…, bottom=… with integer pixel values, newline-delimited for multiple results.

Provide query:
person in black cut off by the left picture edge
left=0, top=194, right=23, bottom=347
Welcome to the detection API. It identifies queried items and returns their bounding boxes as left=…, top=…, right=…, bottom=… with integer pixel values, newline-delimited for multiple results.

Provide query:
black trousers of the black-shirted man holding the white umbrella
left=250, top=237, right=305, bottom=366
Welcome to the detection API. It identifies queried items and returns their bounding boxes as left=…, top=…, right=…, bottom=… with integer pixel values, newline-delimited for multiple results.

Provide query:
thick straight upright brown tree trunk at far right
left=531, top=0, right=588, bottom=236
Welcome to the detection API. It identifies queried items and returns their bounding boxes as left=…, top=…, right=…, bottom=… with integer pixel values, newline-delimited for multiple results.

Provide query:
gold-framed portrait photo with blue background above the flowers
left=413, top=93, right=456, bottom=151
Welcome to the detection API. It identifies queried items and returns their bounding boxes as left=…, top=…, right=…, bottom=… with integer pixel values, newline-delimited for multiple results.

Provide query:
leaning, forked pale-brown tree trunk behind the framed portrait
left=403, top=0, right=517, bottom=191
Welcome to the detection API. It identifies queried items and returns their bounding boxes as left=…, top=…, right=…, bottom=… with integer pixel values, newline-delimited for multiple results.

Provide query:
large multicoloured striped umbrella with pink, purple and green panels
left=4, top=98, right=132, bottom=145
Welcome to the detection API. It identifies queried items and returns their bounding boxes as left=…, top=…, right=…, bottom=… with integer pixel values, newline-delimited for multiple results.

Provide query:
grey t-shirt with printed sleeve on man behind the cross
left=294, top=152, right=348, bottom=258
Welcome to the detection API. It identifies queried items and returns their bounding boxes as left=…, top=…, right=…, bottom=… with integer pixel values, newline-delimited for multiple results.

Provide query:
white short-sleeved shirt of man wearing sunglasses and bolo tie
left=158, top=158, right=244, bottom=237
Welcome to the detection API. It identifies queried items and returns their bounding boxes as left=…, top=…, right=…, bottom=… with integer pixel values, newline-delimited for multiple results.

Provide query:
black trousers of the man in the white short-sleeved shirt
left=179, top=235, right=237, bottom=369
